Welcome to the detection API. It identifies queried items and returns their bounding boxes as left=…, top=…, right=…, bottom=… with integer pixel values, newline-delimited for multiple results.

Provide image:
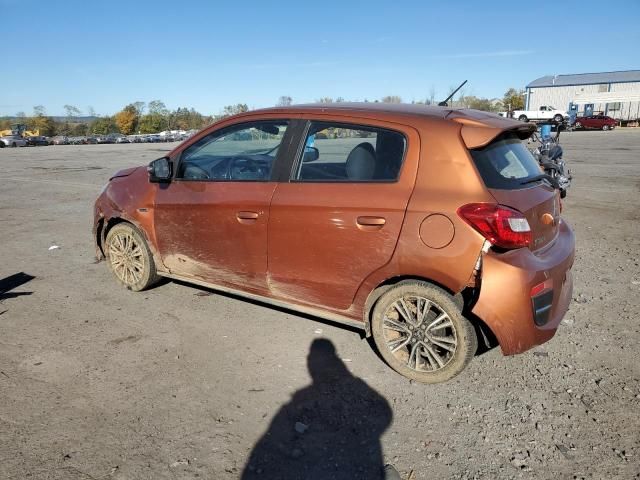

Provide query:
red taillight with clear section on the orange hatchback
left=458, top=203, right=531, bottom=248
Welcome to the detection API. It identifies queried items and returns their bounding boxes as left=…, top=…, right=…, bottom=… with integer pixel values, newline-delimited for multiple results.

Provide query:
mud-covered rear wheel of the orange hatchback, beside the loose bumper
left=371, top=280, right=478, bottom=383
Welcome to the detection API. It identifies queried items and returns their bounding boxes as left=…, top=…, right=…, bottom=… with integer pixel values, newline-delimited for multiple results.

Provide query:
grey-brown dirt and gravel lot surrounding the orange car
left=0, top=130, right=640, bottom=479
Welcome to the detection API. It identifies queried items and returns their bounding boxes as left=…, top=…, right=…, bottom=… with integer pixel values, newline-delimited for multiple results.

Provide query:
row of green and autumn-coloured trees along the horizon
left=0, top=88, right=524, bottom=137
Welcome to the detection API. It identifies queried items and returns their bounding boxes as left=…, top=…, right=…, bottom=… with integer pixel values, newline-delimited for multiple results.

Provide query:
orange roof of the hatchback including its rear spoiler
left=238, top=102, right=536, bottom=148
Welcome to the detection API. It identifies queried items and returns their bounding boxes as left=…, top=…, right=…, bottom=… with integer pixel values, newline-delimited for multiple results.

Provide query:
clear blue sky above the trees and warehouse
left=0, top=0, right=640, bottom=115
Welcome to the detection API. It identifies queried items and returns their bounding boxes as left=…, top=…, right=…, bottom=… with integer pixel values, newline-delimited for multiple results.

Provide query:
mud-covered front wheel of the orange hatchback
left=104, top=223, right=160, bottom=292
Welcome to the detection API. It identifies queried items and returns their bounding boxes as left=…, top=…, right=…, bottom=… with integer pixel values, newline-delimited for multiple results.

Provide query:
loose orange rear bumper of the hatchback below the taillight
left=472, top=221, right=575, bottom=355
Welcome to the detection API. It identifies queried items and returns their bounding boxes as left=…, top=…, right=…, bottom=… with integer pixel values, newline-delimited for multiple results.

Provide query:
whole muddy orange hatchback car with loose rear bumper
left=94, top=103, right=575, bottom=383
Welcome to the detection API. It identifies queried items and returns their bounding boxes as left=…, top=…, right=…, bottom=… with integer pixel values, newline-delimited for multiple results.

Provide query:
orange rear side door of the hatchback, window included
left=268, top=117, right=420, bottom=310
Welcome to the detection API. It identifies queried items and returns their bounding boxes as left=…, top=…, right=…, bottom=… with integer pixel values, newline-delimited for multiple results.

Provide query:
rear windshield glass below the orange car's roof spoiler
left=469, top=134, right=542, bottom=190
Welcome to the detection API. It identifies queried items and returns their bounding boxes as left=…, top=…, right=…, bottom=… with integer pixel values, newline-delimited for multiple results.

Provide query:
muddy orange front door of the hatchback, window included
left=154, top=120, right=288, bottom=294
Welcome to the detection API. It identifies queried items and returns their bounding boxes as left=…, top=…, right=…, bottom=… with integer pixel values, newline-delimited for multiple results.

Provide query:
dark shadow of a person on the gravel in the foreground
left=241, top=339, right=393, bottom=480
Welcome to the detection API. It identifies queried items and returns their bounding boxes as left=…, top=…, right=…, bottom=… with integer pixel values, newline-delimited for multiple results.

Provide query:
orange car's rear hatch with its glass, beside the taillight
left=470, top=132, right=560, bottom=251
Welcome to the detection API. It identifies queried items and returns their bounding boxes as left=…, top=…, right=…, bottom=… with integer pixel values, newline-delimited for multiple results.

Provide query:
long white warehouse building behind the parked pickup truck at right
left=525, top=70, right=640, bottom=121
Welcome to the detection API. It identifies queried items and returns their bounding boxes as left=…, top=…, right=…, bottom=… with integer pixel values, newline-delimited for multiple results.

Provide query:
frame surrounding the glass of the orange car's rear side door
left=288, top=118, right=409, bottom=185
